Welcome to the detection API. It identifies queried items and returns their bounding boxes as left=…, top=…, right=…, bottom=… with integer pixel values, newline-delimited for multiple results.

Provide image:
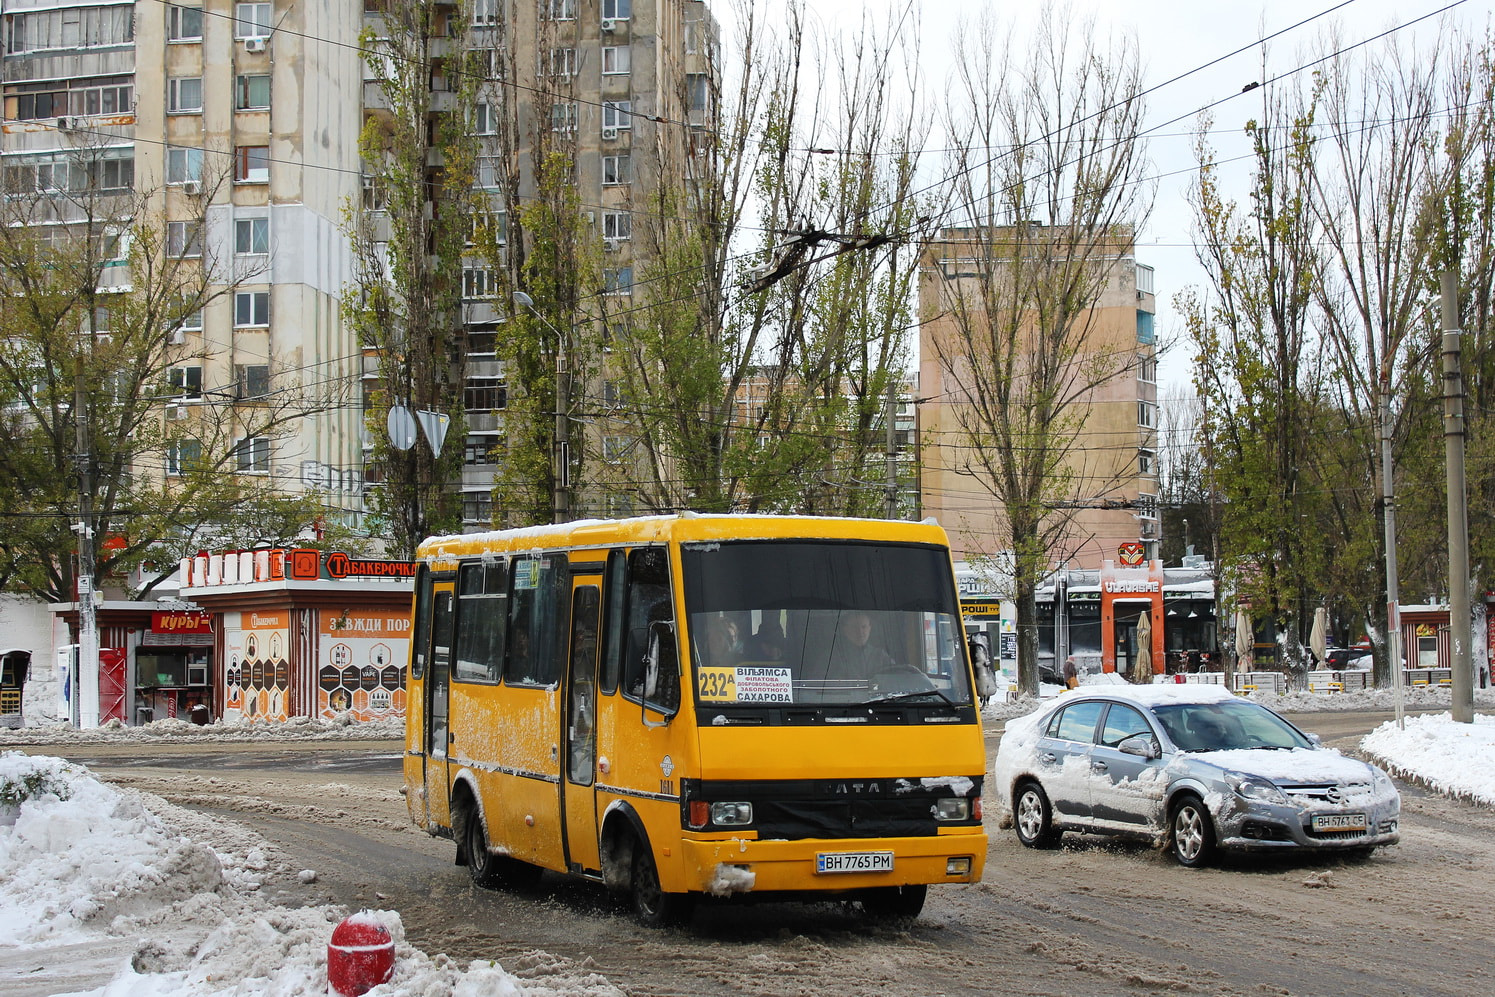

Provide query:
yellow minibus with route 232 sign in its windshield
left=405, top=514, right=987, bottom=925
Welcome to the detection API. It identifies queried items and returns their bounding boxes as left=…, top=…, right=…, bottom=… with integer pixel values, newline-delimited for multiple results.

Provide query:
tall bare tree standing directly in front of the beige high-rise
left=921, top=7, right=1151, bottom=694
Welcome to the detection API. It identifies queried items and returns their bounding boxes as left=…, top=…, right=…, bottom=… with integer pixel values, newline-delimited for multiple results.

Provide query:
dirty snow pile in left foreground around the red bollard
left=0, top=752, right=620, bottom=997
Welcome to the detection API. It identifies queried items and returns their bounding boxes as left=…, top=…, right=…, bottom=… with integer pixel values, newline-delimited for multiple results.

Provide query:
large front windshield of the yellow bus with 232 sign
left=680, top=540, right=970, bottom=707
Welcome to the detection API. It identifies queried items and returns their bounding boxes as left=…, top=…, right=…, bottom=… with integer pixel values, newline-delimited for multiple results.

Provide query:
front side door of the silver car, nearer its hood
left=1090, top=703, right=1168, bottom=834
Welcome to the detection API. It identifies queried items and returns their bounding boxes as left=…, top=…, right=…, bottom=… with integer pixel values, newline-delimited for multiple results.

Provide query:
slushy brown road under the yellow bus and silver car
left=28, top=713, right=1495, bottom=997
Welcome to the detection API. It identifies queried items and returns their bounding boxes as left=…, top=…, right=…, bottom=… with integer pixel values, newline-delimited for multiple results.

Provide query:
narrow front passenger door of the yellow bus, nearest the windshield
left=564, top=575, right=602, bottom=873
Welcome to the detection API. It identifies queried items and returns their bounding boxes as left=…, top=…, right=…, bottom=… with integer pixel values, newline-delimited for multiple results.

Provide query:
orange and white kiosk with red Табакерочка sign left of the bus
left=181, top=550, right=414, bottom=722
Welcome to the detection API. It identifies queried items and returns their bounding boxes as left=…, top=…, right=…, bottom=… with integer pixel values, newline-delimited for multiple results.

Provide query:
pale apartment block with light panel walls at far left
left=0, top=0, right=363, bottom=523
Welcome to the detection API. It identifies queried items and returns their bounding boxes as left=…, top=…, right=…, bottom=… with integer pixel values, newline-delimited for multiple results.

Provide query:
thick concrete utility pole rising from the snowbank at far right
left=1441, top=274, right=1474, bottom=723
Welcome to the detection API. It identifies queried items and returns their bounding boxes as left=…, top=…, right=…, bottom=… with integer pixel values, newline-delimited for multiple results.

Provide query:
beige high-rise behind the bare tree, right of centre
left=919, top=226, right=1159, bottom=570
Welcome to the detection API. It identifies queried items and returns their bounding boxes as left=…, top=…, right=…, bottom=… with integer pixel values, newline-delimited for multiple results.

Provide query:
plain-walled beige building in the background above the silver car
left=918, top=227, right=1160, bottom=570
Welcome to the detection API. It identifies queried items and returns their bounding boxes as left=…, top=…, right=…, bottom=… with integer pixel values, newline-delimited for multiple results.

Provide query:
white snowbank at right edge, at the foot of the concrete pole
left=1360, top=713, right=1495, bottom=804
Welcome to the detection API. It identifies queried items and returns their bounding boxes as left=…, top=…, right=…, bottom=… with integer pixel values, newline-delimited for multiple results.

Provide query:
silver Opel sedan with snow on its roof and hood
left=993, top=685, right=1401, bottom=867
